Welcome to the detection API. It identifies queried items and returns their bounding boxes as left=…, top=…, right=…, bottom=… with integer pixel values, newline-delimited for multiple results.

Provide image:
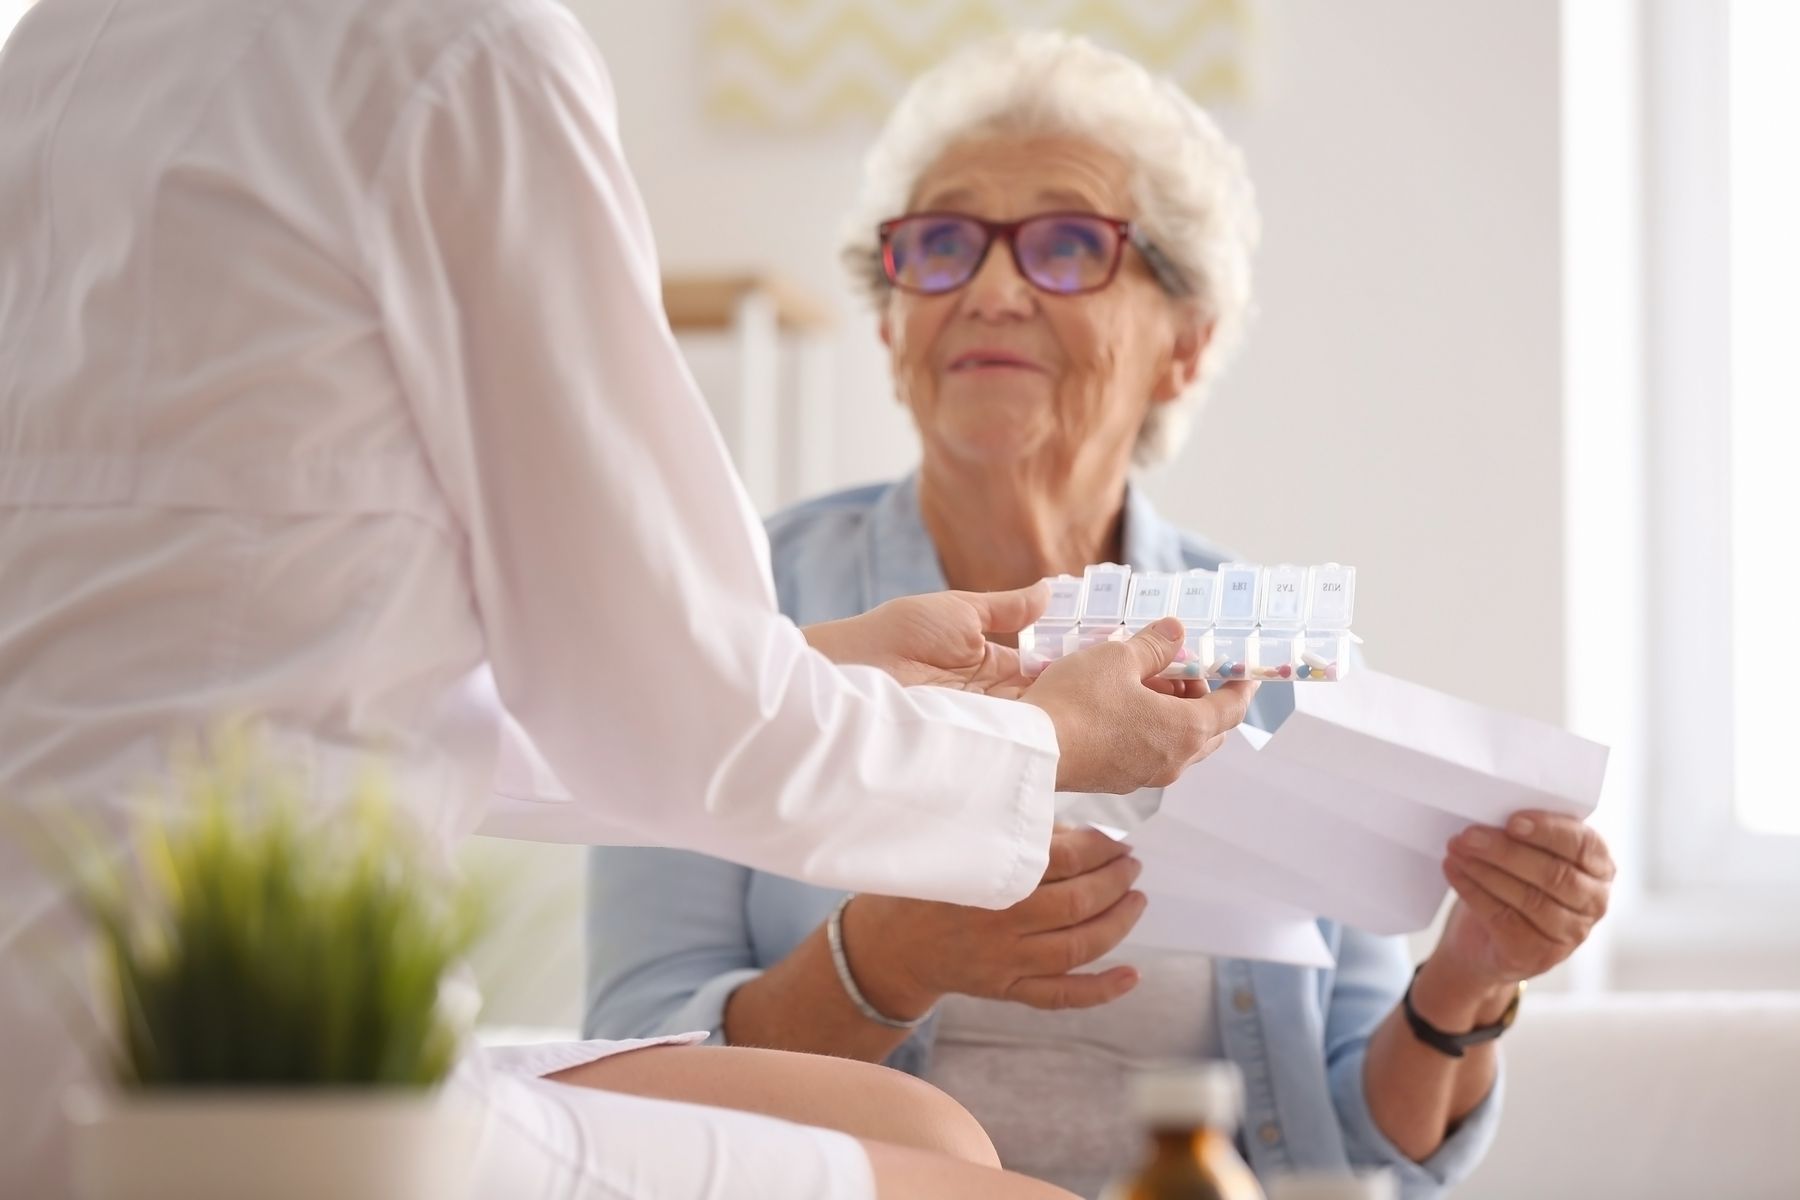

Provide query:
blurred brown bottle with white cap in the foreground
left=1102, top=1063, right=1264, bottom=1200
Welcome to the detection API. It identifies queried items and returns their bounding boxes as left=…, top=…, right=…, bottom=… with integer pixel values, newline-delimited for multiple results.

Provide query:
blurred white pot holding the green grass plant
left=67, top=1088, right=481, bottom=1200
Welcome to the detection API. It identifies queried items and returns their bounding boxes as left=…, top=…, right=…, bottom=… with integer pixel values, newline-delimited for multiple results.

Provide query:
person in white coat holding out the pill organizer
left=0, top=0, right=1247, bottom=1198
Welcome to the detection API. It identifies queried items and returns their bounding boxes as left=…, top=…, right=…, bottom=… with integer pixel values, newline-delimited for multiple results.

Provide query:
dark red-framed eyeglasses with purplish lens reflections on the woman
left=877, top=212, right=1188, bottom=295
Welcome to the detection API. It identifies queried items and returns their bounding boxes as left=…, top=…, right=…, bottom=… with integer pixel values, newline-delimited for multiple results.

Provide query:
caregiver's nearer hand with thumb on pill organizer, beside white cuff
left=1024, top=617, right=1256, bottom=793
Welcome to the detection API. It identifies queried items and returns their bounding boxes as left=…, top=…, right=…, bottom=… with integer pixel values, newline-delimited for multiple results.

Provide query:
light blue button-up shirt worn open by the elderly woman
left=585, top=479, right=1501, bottom=1200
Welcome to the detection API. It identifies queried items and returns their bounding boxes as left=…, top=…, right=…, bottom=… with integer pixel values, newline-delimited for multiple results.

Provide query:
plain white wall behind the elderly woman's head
left=571, top=0, right=1562, bottom=720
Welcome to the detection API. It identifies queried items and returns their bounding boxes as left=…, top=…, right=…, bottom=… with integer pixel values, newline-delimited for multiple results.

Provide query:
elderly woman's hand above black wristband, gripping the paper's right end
left=1433, top=811, right=1616, bottom=986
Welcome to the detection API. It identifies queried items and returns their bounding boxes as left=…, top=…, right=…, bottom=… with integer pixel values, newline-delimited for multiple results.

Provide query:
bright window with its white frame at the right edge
left=1643, top=0, right=1800, bottom=892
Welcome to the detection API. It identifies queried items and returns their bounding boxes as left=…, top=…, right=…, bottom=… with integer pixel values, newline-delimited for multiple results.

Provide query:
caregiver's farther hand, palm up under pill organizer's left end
left=803, top=583, right=1049, bottom=698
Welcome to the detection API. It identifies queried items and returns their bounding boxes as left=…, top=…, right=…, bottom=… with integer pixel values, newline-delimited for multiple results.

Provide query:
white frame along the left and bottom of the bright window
left=1645, top=0, right=1800, bottom=895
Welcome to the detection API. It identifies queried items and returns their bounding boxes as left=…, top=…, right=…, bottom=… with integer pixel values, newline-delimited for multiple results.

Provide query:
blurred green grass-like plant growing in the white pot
left=53, top=729, right=482, bottom=1088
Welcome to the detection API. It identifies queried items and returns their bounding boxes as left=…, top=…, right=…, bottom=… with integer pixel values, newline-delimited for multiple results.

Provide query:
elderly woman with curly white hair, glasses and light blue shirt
left=587, top=34, right=1613, bottom=1196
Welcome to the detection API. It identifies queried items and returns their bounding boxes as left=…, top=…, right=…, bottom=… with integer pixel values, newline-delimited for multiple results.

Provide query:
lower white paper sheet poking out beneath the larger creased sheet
left=1089, top=817, right=1334, bottom=966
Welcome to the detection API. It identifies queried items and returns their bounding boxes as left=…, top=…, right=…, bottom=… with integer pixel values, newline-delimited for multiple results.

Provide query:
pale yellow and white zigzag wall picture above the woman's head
left=706, top=0, right=1251, bottom=128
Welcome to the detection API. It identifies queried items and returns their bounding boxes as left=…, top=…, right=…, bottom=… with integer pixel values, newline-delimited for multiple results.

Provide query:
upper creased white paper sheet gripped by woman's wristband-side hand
left=1132, top=671, right=1607, bottom=934
